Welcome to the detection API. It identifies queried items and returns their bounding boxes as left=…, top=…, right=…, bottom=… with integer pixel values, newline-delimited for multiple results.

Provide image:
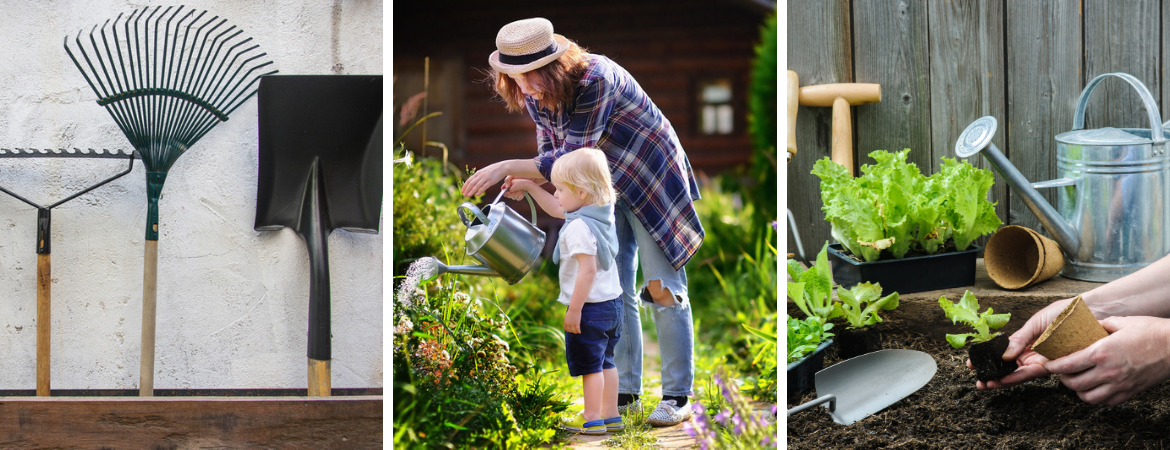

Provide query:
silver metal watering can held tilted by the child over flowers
left=420, top=191, right=545, bottom=284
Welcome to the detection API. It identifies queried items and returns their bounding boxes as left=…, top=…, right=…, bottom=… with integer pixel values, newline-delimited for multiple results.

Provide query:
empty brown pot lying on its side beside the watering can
left=983, top=226, right=1065, bottom=289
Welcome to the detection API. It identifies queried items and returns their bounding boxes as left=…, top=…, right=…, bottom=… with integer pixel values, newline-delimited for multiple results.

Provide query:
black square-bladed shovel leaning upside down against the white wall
left=256, top=75, right=383, bottom=396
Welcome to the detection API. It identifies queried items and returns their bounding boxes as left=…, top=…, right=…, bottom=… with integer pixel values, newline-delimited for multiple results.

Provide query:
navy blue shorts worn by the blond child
left=565, top=297, right=621, bottom=376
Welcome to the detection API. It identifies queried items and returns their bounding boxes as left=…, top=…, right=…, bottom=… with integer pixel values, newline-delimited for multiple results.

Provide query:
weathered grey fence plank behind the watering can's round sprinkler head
left=923, top=0, right=1010, bottom=245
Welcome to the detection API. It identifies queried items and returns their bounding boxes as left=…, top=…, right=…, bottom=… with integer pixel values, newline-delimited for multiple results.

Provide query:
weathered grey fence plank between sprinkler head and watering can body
left=997, top=0, right=1085, bottom=236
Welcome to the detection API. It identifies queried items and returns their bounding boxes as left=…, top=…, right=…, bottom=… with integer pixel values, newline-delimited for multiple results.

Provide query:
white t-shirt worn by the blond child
left=557, top=219, right=621, bottom=305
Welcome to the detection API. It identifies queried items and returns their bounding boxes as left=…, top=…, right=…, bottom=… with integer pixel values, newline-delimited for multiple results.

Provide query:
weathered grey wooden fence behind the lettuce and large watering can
left=786, top=0, right=1170, bottom=257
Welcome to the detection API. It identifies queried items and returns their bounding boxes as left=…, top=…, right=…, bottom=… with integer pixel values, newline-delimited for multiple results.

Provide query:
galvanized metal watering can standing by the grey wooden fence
left=955, top=72, right=1170, bottom=282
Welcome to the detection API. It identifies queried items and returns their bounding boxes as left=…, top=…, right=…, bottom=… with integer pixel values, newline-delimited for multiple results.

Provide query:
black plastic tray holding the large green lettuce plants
left=828, top=243, right=983, bottom=296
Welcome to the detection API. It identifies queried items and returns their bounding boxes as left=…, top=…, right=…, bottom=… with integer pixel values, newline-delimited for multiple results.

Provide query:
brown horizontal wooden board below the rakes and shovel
left=0, top=396, right=383, bottom=449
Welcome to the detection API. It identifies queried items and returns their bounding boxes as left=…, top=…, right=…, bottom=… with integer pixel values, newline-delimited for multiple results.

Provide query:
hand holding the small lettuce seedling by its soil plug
left=966, top=299, right=1072, bottom=390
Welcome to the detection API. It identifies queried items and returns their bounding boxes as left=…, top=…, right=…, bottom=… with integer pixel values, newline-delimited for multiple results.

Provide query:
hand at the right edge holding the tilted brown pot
left=1045, top=317, right=1170, bottom=406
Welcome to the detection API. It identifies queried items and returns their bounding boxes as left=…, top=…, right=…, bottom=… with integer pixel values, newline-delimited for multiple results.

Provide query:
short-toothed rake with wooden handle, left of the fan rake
left=0, top=148, right=135, bottom=396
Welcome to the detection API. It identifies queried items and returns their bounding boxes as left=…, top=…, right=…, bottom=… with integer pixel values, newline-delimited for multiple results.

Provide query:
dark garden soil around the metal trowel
left=787, top=332, right=1170, bottom=449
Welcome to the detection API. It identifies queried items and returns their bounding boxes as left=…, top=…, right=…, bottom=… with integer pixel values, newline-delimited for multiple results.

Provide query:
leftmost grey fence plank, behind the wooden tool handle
left=784, top=0, right=856, bottom=257
